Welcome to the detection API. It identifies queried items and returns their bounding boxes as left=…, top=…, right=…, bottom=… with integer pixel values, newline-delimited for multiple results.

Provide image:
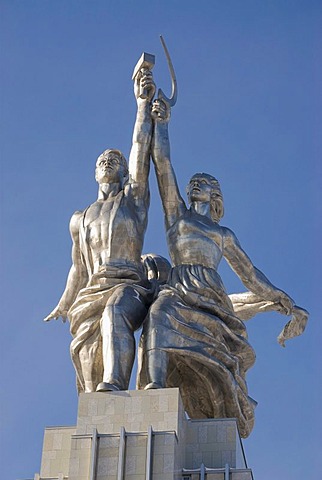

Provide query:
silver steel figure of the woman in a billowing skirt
left=138, top=98, right=307, bottom=437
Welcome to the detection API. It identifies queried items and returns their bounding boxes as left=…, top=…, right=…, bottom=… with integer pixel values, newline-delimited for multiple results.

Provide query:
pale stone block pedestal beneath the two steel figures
left=35, top=388, right=253, bottom=480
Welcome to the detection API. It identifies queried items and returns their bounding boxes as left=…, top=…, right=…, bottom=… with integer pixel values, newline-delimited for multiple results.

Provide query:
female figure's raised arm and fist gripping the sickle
left=151, top=100, right=187, bottom=229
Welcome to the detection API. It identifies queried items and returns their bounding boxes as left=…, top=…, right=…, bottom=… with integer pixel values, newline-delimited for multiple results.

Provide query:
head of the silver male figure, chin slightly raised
left=95, top=149, right=129, bottom=185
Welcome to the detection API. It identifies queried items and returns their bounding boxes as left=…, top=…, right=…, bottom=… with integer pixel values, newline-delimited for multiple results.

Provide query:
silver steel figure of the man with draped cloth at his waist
left=45, top=69, right=155, bottom=392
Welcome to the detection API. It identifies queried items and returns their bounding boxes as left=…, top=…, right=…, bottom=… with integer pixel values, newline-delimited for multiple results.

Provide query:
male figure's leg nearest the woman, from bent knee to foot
left=97, top=286, right=147, bottom=391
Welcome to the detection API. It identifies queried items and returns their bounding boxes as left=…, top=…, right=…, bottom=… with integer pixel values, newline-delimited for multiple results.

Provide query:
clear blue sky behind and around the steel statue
left=0, top=0, right=322, bottom=480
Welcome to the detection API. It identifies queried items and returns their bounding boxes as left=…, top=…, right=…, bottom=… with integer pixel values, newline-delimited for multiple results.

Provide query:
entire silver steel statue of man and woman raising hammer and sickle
left=45, top=39, right=308, bottom=437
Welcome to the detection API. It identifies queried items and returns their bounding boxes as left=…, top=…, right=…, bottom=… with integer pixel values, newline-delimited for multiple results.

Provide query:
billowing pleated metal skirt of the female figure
left=138, top=265, right=256, bottom=437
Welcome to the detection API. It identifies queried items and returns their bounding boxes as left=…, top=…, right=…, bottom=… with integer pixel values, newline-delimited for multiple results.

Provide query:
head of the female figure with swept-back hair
left=187, top=173, right=224, bottom=222
